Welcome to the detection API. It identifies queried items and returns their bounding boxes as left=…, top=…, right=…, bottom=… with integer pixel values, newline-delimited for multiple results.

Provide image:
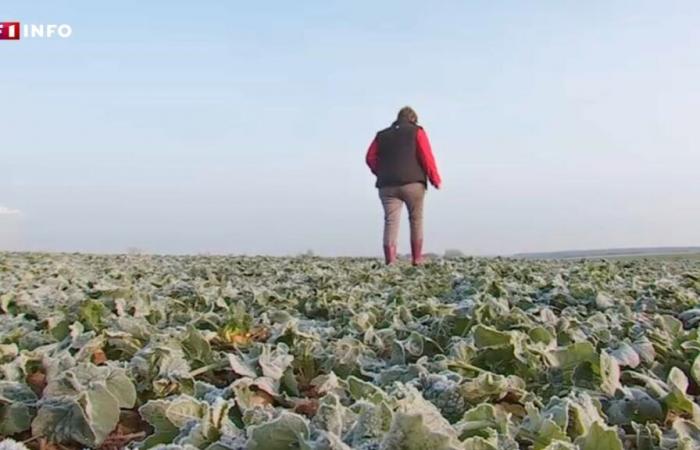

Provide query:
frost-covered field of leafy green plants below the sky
left=0, top=254, right=700, bottom=450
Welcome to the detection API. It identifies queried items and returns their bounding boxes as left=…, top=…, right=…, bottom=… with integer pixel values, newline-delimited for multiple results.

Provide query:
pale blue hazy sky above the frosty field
left=0, top=0, right=700, bottom=255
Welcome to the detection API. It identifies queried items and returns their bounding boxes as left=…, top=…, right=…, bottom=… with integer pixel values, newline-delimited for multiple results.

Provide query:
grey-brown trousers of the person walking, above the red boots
left=379, top=183, right=425, bottom=245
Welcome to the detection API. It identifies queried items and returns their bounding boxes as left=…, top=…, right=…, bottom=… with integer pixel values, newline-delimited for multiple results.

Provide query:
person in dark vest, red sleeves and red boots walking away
left=365, top=106, right=442, bottom=265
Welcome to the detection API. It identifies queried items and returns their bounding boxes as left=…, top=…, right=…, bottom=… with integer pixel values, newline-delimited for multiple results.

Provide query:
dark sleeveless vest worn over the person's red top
left=376, top=121, right=427, bottom=188
